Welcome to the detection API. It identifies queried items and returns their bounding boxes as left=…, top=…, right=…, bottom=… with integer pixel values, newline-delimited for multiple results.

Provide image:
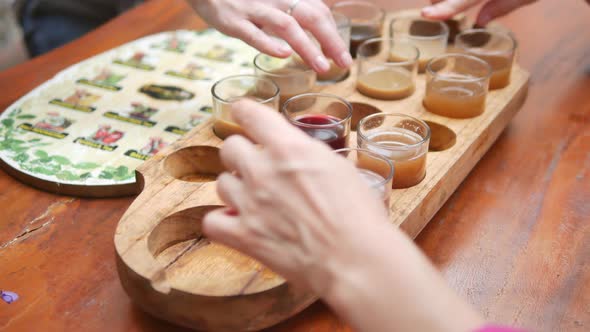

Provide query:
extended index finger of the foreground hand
left=231, top=100, right=313, bottom=152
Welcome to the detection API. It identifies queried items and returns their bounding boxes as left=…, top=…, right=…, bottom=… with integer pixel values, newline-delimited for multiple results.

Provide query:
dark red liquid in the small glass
left=295, top=114, right=348, bottom=150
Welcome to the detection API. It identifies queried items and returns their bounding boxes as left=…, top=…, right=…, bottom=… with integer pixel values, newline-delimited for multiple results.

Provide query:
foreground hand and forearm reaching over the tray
left=203, top=101, right=483, bottom=331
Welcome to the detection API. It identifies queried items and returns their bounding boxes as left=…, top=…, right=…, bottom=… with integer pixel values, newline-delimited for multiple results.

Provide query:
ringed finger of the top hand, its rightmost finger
left=293, top=2, right=352, bottom=68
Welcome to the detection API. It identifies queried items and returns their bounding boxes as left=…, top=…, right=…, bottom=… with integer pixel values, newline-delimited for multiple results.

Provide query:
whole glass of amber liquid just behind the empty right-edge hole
left=423, top=54, right=492, bottom=119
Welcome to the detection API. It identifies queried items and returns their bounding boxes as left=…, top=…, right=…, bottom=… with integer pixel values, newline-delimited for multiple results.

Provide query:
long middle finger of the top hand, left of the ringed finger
left=252, top=6, right=330, bottom=73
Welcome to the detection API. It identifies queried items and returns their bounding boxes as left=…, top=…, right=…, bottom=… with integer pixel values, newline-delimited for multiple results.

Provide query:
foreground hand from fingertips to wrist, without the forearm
left=203, top=101, right=391, bottom=296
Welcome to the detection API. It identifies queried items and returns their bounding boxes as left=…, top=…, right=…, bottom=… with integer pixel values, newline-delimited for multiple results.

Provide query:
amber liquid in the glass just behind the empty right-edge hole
left=424, top=81, right=487, bottom=119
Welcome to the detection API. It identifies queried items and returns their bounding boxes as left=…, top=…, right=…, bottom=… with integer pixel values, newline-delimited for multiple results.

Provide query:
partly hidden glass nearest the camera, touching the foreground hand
left=334, top=149, right=394, bottom=208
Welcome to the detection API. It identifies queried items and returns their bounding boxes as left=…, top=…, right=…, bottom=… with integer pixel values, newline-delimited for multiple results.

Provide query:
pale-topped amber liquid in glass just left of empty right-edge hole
left=367, top=128, right=428, bottom=189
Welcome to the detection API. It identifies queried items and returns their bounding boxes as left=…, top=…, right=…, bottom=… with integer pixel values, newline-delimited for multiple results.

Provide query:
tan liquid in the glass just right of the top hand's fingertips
left=356, top=68, right=415, bottom=100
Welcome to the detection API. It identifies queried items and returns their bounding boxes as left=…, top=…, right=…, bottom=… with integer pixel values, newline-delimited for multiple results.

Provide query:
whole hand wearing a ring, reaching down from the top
left=189, top=0, right=352, bottom=73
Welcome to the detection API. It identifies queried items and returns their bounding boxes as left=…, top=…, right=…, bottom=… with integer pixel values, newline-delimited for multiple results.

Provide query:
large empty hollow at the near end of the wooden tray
left=147, top=205, right=284, bottom=296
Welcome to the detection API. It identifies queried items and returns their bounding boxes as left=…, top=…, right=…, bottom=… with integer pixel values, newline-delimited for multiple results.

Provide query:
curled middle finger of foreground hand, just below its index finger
left=220, top=135, right=261, bottom=179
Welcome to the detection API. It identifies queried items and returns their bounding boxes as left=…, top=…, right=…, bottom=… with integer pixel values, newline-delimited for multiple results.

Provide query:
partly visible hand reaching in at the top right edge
left=422, top=0, right=536, bottom=26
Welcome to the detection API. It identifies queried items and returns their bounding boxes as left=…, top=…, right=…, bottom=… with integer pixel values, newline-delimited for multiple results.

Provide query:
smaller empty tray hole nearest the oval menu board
left=164, top=146, right=224, bottom=182
